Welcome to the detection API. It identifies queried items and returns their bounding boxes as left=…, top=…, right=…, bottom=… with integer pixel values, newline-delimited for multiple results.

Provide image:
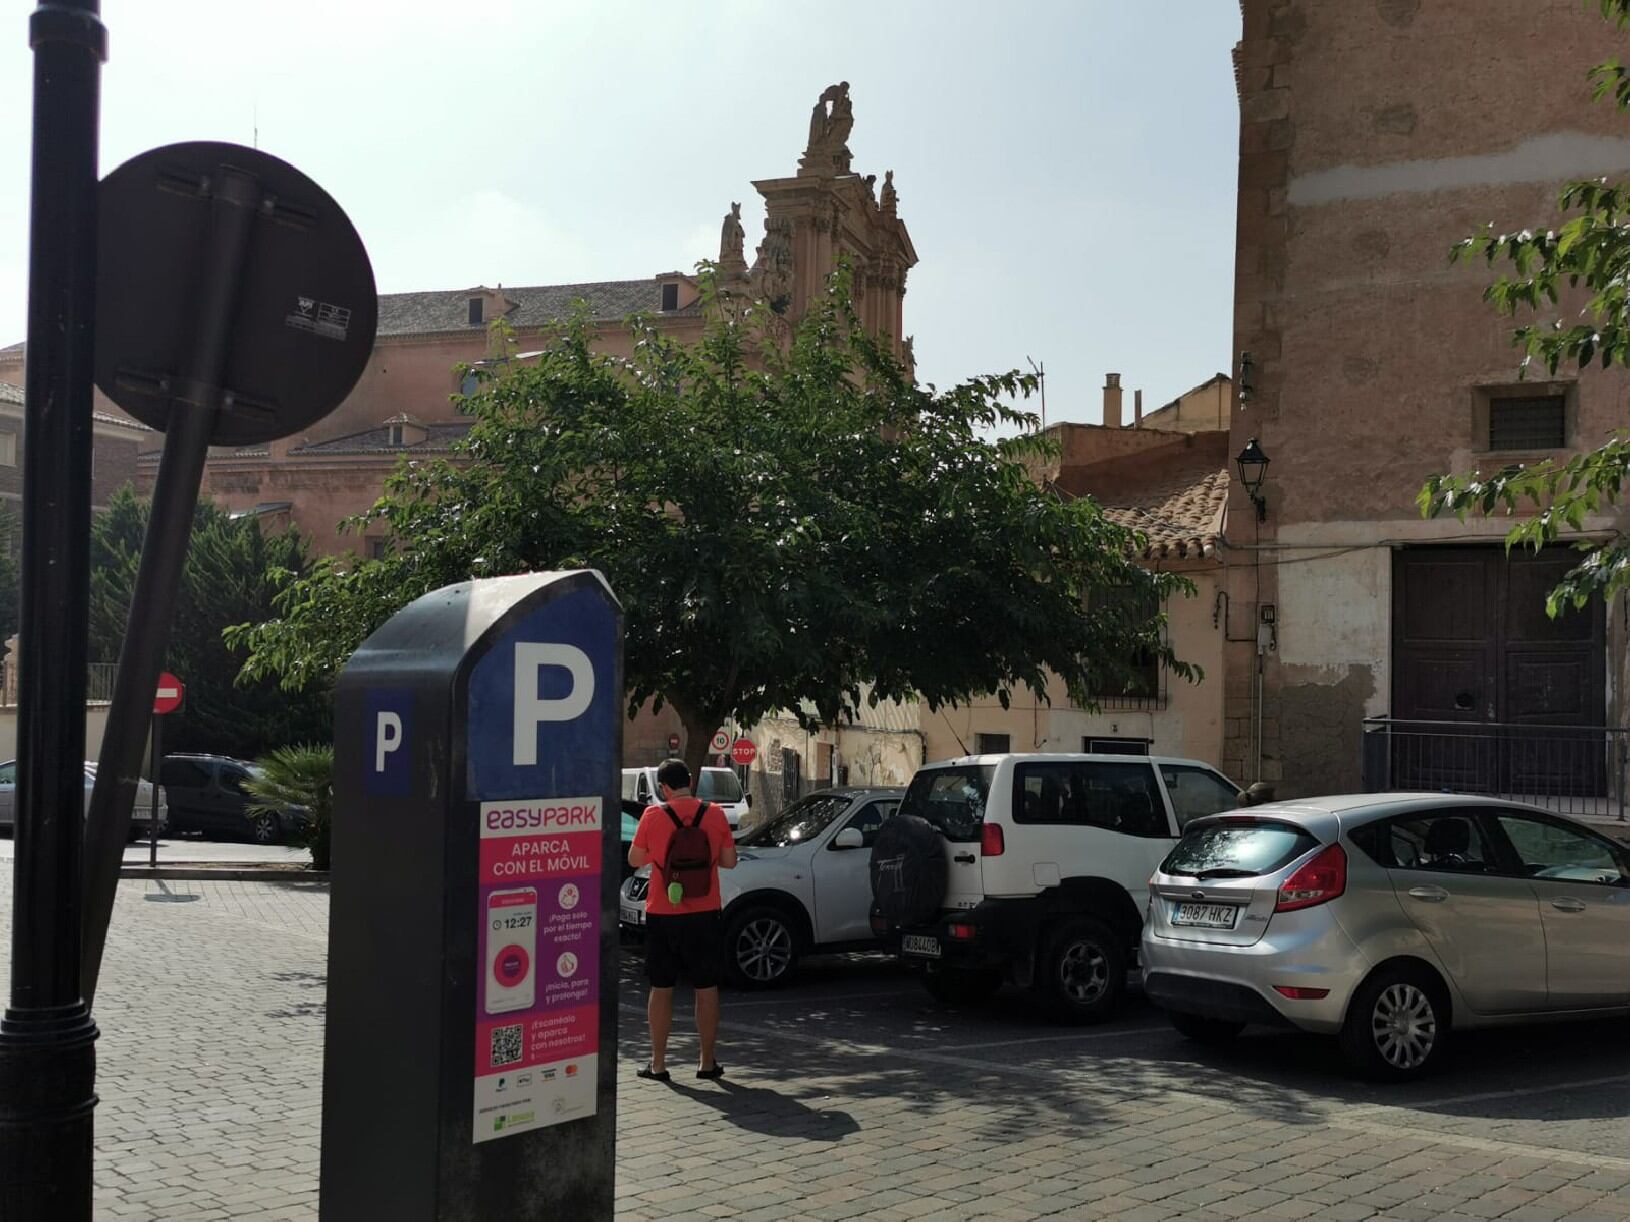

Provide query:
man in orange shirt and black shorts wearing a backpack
left=628, top=759, right=735, bottom=1082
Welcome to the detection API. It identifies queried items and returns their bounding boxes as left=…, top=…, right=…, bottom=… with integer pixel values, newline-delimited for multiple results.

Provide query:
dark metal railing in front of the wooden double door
left=1363, top=717, right=1630, bottom=823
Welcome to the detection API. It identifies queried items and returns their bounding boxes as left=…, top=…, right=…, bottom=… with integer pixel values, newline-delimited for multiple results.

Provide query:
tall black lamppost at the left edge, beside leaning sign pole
left=0, top=0, right=108, bottom=1222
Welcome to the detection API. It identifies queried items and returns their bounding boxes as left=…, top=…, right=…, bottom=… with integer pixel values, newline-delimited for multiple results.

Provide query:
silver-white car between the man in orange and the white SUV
left=618, top=789, right=905, bottom=989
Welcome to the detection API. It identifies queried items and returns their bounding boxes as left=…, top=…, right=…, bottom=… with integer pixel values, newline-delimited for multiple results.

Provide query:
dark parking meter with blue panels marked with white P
left=319, top=572, right=623, bottom=1222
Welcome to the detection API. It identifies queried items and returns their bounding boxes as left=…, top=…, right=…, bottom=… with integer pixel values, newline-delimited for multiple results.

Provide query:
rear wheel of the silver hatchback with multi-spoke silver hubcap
left=1340, top=965, right=1449, bottom=1082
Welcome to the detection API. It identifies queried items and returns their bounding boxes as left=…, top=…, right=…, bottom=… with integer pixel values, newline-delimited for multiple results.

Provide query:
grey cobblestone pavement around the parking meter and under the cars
left=12, top=872, right=1630, bottom=1222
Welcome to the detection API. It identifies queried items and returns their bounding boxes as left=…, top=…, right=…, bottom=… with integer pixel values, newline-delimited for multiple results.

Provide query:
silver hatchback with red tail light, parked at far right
left=1143, top=793, right=1630, bottom=1079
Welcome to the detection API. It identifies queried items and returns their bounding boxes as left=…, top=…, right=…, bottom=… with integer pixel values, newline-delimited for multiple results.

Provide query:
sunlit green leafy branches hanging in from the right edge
left=1420, top=0, right=1630, bottom=616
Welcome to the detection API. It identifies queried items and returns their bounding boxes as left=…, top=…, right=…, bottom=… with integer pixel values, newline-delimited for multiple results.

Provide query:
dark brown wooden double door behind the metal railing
left=1392, top=546, right=1607, bottom=797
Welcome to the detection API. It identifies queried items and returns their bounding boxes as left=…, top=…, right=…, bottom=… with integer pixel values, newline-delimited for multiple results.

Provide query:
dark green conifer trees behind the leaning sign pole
left=90, top=489, right=331, bottom=759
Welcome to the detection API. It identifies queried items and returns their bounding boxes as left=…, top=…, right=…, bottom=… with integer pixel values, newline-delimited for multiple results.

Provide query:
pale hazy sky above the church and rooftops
left=0, top=0, right=1239, bottom=420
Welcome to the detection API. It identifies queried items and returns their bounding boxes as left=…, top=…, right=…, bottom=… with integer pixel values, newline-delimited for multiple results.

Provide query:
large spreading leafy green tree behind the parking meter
left=230, top=274, right=1195, bottom=766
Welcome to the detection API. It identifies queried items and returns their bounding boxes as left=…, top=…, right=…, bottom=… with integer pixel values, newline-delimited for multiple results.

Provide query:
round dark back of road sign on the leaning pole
left=96, top=142, right=380, bottom=445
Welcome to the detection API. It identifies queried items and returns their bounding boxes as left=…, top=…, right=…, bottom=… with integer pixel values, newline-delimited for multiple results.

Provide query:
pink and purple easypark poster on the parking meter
left=474, top=797, right=603, bottom=1142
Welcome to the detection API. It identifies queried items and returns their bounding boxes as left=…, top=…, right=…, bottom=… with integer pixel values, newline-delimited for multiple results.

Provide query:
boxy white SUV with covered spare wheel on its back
left=870, top=754, right=1239, bottom=1022
